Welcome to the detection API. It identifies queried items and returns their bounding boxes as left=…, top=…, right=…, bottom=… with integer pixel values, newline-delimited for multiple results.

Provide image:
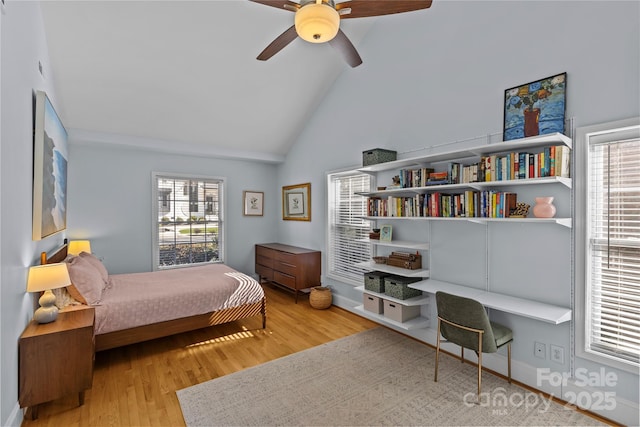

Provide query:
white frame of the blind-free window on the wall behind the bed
left=151, top=171, right=227, bottom=271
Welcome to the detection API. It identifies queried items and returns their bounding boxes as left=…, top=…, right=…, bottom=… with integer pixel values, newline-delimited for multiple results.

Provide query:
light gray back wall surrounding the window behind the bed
left=67, top=144, right=279, bottom=274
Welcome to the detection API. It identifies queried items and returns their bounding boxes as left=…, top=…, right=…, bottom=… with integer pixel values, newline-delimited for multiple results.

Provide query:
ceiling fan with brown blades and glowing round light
left=251, top=0, right=432, bottom=67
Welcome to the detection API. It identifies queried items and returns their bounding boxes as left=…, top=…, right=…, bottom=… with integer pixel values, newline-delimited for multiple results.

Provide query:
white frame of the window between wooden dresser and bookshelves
left=325, top=167, right=376, bottom=287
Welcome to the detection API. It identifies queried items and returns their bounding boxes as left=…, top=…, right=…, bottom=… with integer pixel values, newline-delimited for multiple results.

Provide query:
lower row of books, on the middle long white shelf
left=367, top=190, right=517, bottom=218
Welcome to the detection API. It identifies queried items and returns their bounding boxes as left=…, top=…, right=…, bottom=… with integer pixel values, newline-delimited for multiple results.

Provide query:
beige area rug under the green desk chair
left=177, top=327, right=601, bottom=427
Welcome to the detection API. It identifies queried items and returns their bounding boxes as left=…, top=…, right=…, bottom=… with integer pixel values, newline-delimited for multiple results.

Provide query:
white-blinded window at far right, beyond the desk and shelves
left=575, top=120, right=640, bottom=369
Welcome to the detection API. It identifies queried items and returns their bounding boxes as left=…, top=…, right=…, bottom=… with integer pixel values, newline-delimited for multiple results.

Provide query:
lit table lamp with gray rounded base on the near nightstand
left=27, top=263, right=71, bottom=323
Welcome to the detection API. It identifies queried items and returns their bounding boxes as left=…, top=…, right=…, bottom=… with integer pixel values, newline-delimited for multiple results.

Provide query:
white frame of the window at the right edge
left=573, top=118, right=640, bottom=373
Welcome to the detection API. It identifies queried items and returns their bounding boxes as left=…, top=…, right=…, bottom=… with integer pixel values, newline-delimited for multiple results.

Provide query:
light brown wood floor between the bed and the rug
left=22, top=284, right=376, bottom=427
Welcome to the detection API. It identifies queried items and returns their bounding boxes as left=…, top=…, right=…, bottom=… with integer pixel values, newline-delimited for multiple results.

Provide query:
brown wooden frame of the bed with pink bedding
left=40, top=243, right=267, bottom=351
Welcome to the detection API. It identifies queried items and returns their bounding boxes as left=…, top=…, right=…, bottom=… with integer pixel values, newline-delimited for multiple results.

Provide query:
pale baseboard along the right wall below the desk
left=333, top=294, right=640, bottom=426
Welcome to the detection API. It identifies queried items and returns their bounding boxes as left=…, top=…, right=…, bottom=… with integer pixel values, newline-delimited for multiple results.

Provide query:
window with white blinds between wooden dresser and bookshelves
left=327, top=171, right=372, bottom=285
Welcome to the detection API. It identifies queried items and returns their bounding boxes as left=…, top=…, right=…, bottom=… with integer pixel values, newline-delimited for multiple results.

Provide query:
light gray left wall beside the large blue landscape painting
left=0, top=2, right=64, bottom=425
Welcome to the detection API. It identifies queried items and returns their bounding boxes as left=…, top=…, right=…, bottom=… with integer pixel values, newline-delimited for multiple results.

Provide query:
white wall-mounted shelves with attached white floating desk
left=356, top=133, right=572, bottom=329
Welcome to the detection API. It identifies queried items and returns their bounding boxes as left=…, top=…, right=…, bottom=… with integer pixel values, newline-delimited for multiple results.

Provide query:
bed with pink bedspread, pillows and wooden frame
left=41, top=244, right=266, bottom=351
